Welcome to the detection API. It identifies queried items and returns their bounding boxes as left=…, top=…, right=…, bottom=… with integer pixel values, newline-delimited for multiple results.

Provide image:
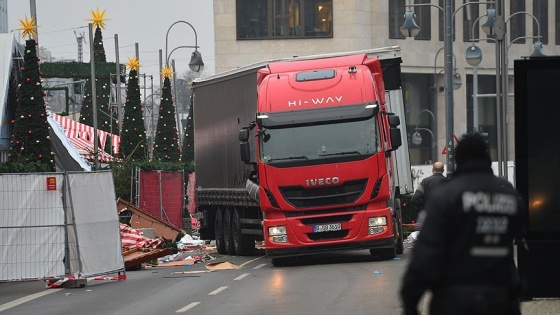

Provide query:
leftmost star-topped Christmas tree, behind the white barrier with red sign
left=9, top=16, right=55, bottom=171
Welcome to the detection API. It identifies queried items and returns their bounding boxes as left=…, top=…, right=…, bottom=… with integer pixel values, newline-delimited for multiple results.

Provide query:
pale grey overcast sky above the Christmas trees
left=8, top=0, right=214, bottom=85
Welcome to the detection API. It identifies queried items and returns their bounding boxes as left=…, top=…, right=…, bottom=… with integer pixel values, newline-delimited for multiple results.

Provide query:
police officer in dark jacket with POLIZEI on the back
left=400, top=135, right=521, bottom=315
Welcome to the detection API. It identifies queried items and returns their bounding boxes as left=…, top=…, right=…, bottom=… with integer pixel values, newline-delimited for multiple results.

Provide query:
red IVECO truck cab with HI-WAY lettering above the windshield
left=239, top=54, right=403, bottom=264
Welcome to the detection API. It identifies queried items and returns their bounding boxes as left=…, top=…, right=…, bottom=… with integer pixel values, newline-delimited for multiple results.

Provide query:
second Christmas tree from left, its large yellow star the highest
left=79, top=8, right=119, bottom=134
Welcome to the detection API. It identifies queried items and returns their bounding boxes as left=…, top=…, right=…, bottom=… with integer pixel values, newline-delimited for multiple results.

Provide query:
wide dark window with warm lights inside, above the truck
left=236, top=0, right=333, bottom=39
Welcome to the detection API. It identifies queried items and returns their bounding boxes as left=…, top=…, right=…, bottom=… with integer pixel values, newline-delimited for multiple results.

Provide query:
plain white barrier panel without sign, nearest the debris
left=67, top=171, right=124, bottom=277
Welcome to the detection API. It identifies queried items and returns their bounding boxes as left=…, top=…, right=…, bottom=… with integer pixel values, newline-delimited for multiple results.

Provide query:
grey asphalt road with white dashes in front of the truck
left=0, top=250, right=408, bottom=315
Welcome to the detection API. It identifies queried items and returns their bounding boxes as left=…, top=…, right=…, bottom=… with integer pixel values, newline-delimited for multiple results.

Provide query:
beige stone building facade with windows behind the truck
left=214, top=0, right=560, bottom=165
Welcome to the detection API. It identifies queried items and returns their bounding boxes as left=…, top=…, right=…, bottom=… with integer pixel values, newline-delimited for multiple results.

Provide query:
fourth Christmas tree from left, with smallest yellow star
left=153, top=66, right=181, bottom=162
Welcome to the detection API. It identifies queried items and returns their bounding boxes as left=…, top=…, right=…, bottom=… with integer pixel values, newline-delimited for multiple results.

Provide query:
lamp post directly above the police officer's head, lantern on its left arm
left=401, top=0, right=494, bottom=177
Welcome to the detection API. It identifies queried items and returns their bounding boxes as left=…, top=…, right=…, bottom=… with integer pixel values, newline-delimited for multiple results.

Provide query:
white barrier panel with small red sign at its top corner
left=0, top=173, right=65, bottom=281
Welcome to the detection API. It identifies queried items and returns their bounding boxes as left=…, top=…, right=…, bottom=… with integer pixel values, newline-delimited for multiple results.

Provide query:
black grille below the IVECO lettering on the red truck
left=279, top=179, right=367, bottom=208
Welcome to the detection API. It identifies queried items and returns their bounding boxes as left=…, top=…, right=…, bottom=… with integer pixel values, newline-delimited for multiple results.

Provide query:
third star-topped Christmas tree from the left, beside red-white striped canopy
left=119, top=58, right=147, bottom=161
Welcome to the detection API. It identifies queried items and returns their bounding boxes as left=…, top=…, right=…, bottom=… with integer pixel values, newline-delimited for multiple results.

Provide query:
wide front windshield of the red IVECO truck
left=258, top=116, right=380, bottom=164
